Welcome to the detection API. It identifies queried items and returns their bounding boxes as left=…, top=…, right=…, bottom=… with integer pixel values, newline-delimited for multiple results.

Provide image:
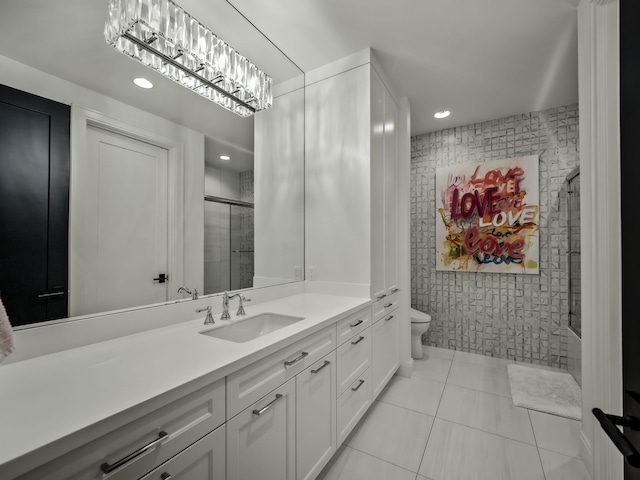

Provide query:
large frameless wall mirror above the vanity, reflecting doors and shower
left=0, top=0, right=304, bottom=328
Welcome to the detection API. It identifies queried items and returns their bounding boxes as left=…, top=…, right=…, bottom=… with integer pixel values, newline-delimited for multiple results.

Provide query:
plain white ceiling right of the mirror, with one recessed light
left=231, top=0, right=579, bottom=135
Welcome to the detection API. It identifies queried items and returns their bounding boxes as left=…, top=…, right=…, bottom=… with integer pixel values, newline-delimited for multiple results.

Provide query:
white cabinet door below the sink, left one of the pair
left=227, top=378, right=296, bottom=480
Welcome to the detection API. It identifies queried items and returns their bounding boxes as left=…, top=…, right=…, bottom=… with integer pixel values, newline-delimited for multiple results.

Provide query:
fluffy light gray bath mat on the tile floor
left=507, top=364, right=582, bottom=420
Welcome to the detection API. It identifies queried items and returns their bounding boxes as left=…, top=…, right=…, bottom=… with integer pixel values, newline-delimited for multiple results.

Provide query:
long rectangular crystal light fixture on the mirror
left=104, top=0, right=273, bottom=117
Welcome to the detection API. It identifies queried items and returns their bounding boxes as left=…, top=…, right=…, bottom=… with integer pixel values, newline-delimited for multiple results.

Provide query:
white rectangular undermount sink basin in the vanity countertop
left=200, top=313, right=303, bottom=343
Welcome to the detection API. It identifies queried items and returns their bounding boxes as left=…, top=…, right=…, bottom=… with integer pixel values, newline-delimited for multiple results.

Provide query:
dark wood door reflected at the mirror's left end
left=0, top=85, right=70, bottom=326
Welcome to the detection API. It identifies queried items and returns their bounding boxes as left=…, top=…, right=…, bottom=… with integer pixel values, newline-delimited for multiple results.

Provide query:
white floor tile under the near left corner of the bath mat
left=437, top=384, right=536, bottom=445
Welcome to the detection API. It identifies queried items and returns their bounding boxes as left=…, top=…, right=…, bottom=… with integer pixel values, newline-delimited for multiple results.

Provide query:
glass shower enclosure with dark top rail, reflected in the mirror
left=204, top=195, right=254, bottom=295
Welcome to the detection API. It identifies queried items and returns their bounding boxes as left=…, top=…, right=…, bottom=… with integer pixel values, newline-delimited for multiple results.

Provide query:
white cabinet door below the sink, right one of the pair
left=296, top=351, right=336, bottom=480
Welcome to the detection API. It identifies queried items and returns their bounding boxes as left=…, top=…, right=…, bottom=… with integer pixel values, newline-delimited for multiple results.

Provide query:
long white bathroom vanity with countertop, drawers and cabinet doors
left=0, top=293, right=399, bottom=480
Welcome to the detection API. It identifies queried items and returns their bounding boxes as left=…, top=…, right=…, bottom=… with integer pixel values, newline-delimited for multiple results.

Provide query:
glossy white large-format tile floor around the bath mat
left=319, top=347, right=590, bottom=480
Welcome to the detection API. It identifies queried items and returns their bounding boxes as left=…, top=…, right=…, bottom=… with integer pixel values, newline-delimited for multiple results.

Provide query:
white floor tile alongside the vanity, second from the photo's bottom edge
left=347, top=402, right=433, bottom=472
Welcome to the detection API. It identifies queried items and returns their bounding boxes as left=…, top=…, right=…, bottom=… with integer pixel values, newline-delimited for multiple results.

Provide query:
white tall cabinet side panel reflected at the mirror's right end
left=253, top=89, right=305, bottom=286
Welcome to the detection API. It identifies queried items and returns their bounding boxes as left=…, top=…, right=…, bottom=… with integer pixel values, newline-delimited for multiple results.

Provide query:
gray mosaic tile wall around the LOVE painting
left=411, top=105, right=578, bottom=368
